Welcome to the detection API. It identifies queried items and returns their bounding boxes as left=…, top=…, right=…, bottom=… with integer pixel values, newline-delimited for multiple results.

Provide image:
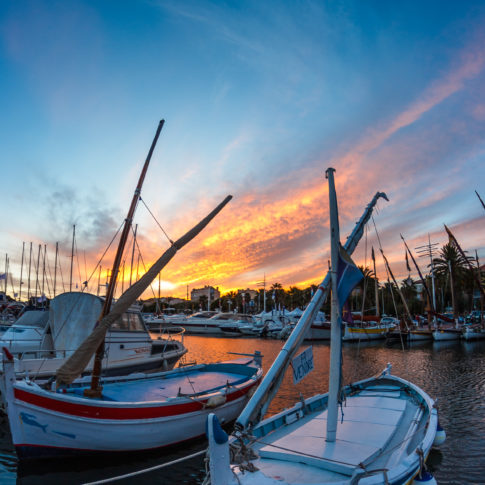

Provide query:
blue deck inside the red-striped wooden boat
left=68, top=370, right=249, bottom=402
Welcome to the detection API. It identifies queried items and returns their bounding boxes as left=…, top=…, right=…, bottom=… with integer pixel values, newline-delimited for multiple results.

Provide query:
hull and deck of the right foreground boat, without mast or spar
left=221, top=375, right=438, bottom=485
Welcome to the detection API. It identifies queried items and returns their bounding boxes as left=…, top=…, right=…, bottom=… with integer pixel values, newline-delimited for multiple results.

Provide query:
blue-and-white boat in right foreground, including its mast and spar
left=207, top=169, right=438, bottom=485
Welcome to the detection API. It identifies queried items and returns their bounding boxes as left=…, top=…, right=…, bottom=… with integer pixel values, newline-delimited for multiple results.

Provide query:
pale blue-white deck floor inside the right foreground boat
left=248, top=390, right=419, bottom=484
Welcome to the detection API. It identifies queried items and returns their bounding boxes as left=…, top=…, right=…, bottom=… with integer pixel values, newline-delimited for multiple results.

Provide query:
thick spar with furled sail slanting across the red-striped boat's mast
left=56, top=195, right=232, bottom=385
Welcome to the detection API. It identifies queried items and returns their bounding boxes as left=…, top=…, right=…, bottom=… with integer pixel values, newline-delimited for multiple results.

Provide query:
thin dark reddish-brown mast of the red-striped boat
left=90, top=120, right=165, bottom=394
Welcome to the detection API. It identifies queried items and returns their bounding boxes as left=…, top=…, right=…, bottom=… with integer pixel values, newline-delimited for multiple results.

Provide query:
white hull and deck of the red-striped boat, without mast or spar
left=4, top=350, right=262, bottom=459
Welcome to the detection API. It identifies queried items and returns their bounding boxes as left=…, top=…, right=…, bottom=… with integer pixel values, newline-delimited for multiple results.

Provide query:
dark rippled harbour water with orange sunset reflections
left=0, top=336, right=485, bottom=485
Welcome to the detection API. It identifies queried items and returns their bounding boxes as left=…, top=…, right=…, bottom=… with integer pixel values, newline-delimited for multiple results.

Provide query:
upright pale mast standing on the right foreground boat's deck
left=326, top=168, right=342, bottom=442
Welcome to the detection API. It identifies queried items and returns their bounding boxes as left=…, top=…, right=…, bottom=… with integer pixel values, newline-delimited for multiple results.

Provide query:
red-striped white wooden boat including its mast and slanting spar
left=3, top=121, right=262, bottom=458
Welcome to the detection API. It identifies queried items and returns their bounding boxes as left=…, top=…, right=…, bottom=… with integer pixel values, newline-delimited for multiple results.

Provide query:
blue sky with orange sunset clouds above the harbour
left=0, top=0, right=485, bottom=297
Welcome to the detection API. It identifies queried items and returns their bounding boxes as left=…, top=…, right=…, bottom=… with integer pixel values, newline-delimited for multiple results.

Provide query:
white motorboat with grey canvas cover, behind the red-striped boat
left=0, top=292, right=187, bottom=384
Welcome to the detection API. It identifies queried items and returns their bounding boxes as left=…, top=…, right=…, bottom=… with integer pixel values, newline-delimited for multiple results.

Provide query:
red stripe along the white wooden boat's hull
left=14, top=381, right=259, bottom=420
